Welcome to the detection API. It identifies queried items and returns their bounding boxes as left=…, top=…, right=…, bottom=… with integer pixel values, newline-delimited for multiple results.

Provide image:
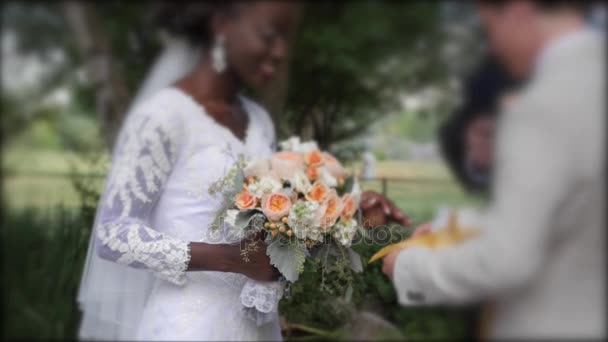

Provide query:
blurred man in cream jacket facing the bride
left=383, top=0, right=606, bottom=338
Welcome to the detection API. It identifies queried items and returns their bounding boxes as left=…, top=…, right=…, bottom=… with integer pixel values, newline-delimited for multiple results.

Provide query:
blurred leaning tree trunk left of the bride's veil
left=63, top=0, right=131, bottom=148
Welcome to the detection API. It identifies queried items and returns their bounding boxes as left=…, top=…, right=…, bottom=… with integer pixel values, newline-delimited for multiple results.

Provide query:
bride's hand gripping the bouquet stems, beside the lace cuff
left=236, top=232, right=281, bottom=281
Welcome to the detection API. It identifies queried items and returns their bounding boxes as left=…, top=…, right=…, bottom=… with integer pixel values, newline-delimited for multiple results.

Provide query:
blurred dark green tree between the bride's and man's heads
left=278, top=1, right=446, bottom=147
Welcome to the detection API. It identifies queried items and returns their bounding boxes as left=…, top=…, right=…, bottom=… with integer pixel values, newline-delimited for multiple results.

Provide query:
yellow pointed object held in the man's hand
left=369, top=212, right=479, bottom=263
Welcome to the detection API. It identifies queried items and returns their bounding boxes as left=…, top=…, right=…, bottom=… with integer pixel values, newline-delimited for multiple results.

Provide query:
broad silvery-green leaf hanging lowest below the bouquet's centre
left=266, top=238, right=306, bottom=283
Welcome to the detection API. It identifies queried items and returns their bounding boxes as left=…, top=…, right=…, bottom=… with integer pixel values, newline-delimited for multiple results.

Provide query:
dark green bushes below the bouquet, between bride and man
left=279, top=225, right=473, bottom=341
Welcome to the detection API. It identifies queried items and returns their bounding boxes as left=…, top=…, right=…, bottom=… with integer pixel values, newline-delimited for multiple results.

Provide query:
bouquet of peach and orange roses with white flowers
left=210, top=137, right=363, bottom=283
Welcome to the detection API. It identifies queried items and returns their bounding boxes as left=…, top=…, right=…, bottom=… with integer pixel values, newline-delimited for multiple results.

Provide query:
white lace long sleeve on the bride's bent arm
left=95, top=107, right=190, bottom=285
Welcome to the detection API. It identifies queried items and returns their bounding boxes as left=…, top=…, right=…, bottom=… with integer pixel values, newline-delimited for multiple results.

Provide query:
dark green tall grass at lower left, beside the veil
left=2, top=207, right=90, bottom=340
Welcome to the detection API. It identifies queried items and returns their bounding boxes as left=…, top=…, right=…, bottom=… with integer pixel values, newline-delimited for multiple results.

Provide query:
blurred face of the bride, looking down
left=214, top=1, right=299, bottom=88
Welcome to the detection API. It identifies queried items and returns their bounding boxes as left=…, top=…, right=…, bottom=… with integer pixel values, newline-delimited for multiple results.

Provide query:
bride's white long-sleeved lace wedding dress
left=81, top=87, right=281, bottom=341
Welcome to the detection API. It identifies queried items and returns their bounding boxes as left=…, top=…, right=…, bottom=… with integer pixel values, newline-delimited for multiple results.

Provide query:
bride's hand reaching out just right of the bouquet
left=361, top=191, right=411, bottom=228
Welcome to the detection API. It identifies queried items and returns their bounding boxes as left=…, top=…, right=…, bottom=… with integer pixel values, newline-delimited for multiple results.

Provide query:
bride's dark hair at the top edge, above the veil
left=152, top=0, right=237, bottom=46
